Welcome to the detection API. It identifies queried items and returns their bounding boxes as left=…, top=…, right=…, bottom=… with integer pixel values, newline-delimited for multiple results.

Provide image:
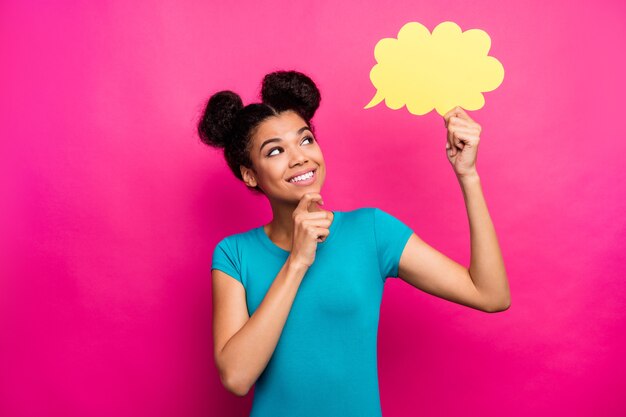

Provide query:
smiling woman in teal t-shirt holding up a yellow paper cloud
left=198, top=71, right=510, bottom=417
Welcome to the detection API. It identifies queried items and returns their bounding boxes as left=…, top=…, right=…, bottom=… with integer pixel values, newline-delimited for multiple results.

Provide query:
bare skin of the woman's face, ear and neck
left=241, top=110, right=334, bottom=251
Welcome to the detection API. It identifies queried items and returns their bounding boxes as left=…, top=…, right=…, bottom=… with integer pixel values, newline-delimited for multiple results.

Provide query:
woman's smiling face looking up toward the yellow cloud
left=241, top=111, right=326, bottom=205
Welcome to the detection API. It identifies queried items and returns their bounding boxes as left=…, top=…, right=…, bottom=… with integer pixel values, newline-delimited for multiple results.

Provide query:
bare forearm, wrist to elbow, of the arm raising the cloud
left=459, top=174, right=511, bottom=310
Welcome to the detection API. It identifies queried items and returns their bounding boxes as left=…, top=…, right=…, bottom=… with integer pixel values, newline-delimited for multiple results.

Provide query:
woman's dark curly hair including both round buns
left=198, top=71, right=321, bottom=194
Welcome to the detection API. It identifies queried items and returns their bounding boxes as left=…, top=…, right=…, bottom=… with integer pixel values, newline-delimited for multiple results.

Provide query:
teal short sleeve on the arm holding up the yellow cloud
left=374, top=208, right=413, bottom=281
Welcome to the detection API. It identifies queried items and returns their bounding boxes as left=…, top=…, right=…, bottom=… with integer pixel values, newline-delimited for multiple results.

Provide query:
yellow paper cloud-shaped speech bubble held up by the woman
left=365, top=22, right=504, bottom=116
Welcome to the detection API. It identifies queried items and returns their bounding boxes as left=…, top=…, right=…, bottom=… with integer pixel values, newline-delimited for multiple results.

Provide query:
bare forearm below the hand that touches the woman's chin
left=220, top=257, right=308, bottom=395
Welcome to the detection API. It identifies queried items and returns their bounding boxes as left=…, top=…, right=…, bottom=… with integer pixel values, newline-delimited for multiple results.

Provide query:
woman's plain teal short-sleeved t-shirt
left=211, top=207, right=413, bottom=417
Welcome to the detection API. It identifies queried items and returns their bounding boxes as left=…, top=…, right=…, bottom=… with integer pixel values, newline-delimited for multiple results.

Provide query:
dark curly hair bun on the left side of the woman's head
left=198, top=90, right=243, bottom=148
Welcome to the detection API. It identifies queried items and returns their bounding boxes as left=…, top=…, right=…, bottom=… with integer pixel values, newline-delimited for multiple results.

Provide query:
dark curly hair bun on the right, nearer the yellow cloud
left=261, top=71, right=321, bottom=121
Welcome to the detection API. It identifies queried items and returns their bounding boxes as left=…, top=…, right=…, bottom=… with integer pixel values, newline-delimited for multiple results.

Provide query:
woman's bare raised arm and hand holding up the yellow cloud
left=398, top=107, right=511, bottom=312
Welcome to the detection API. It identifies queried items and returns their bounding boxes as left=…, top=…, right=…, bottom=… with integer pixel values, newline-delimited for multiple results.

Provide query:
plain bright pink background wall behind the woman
left=0, top=0, right=626, bottom=417
